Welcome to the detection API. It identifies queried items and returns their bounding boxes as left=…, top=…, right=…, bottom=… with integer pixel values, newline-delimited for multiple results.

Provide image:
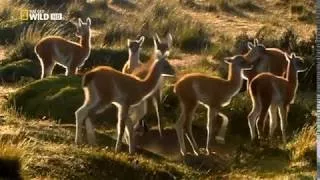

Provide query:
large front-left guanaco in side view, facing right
left=75, top=48, right=175, bottom=153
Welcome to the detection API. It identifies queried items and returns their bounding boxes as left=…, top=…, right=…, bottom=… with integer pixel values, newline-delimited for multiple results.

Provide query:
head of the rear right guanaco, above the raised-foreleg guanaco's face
left=245, top=39, right=266, bottom=63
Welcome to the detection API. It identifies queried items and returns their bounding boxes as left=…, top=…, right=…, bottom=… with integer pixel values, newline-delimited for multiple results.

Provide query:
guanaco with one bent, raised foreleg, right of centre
left=174, top=55, right=251, bottom=155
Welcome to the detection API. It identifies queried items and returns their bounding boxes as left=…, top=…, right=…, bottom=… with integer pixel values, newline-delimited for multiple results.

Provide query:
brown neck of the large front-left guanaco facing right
left=140, top=60, right=165, bottom=98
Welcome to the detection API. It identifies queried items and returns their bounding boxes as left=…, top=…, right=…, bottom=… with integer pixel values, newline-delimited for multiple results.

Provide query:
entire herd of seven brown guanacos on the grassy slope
left=34, top=18, right=306, bottom=155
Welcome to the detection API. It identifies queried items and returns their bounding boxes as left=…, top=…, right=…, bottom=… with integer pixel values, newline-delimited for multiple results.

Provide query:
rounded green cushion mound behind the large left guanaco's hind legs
left=8, top=76, right=84, bottom=122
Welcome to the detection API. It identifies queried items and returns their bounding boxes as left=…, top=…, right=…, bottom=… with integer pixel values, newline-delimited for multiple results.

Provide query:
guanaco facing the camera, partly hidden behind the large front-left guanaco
left=124, top=33, right=172, bottom=137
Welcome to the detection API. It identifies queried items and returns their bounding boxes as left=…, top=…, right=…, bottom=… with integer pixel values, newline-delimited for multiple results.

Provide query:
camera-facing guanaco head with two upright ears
left=153, top=33, right=172, bottom=58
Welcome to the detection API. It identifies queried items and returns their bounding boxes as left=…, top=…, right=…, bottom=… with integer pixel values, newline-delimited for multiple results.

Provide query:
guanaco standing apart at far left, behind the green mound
left=34, top=18, right=91, bottom=79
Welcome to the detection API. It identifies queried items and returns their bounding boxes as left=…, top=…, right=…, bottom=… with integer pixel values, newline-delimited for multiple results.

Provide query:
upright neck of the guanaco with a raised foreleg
left=227, top=64, right=243, bottom=93
